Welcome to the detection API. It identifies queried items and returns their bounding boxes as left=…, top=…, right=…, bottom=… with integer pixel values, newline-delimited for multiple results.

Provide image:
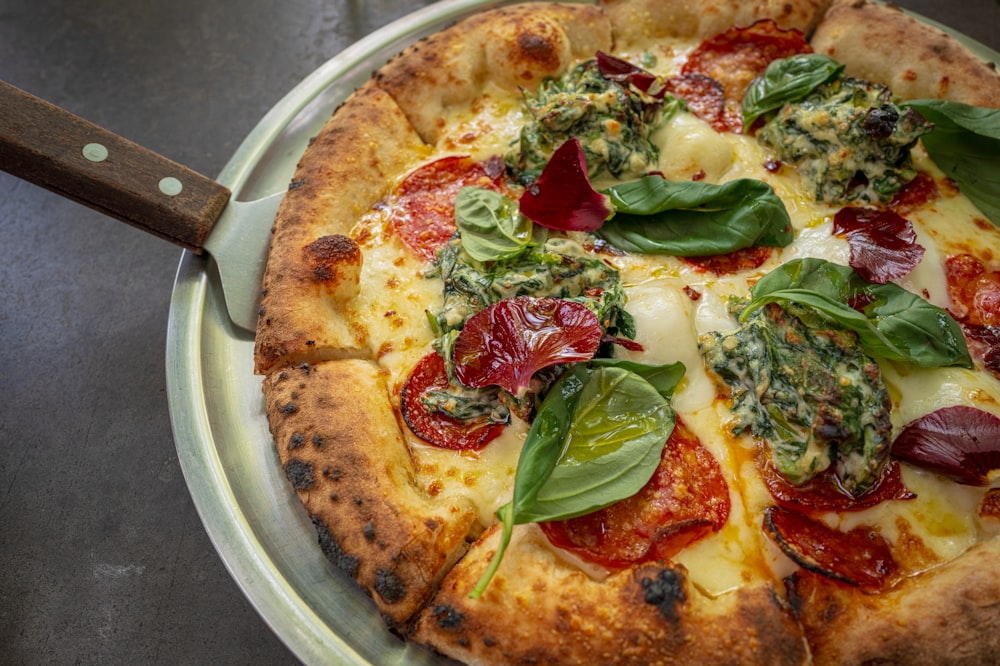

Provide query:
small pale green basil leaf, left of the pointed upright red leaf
left=455, top=187, right=547, bottom=262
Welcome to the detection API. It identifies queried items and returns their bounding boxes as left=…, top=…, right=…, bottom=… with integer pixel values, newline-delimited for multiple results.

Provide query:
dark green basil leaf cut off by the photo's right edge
left=901, top=99, right=1000, bottom=226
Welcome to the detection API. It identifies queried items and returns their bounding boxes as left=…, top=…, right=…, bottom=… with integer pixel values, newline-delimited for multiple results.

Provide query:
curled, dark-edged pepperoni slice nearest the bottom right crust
left=764, top=506, right=897, bottom=592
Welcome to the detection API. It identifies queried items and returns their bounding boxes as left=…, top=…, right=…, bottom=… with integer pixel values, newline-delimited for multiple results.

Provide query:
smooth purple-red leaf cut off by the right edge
left=892, top=405, right=1000, bottom=486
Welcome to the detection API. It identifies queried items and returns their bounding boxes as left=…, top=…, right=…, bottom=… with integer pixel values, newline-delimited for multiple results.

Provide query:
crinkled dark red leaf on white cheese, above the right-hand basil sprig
left=833, top=208, right=924, bottom=284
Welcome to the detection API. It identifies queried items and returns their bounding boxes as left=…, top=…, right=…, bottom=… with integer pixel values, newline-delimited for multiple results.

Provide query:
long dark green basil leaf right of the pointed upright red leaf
left=596, top=176, right=793, bottom=257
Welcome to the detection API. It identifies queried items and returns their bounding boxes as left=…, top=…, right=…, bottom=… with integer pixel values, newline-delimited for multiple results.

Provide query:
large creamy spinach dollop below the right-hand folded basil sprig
left=700, top=303, right=892, bottom=497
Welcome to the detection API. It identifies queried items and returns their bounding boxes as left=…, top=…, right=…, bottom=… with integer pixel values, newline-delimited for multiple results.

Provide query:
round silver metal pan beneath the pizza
left=166, top=0, right=1000, bottom=665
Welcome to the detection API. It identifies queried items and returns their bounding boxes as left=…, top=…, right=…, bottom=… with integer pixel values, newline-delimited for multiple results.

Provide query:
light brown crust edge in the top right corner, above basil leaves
left=810, top=0, right=1000, bottom=108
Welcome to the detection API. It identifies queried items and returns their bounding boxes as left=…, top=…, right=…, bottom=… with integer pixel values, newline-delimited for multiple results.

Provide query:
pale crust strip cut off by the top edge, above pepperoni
left=601, top=0, right=830, bottom=46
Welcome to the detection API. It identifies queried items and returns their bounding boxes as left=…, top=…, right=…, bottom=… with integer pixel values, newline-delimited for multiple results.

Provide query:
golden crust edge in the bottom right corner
left=792, top=538, right=1000, bottom=666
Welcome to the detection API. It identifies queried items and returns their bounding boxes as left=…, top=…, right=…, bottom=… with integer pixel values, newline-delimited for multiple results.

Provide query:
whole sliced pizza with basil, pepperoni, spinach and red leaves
left=255, top=0, right=1000, bottom=664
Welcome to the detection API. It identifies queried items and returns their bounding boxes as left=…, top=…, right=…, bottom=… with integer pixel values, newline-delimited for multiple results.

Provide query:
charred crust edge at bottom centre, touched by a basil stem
left=414, top=525, right=808, bottom=666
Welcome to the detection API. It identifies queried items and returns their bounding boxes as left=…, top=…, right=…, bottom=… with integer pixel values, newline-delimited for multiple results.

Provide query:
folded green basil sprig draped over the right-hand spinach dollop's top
left=740, top=258, right=972, bottom=368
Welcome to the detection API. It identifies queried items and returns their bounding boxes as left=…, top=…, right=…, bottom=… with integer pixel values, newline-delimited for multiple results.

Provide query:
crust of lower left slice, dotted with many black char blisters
left=264, top=359, right=475, bottom=624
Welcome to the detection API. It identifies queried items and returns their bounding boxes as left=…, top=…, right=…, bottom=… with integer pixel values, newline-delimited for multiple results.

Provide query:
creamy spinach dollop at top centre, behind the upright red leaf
left=506, top=60, right=680, bottom=184
